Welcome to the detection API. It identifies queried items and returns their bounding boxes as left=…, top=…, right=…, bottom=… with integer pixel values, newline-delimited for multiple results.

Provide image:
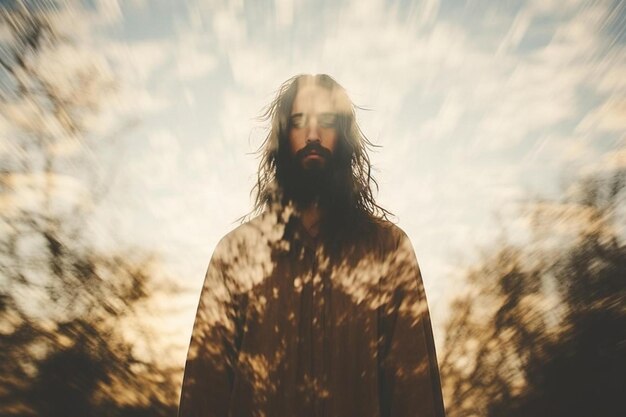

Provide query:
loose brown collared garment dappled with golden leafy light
left=179, top=214, right=444, bottom=417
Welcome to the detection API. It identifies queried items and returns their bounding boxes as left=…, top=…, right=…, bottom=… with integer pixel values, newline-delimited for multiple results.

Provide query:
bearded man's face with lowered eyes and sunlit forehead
left=289, top=84, right=338, bottom=169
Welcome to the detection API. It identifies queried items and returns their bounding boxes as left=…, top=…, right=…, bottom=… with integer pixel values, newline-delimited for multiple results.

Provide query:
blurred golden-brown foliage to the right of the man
left=441, top=171, right=626, bottom=417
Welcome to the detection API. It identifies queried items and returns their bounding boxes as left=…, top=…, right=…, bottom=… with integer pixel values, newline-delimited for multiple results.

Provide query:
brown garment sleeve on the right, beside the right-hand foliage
left=379, top=233, right=445, bottom=417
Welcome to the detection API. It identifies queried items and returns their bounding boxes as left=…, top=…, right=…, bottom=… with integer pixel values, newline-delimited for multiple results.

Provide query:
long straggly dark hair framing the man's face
left=251, top=74, right=391, bottom=232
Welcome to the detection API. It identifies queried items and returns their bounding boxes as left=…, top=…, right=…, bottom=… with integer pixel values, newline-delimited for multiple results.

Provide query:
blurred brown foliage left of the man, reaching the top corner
left=0, top=1, right=181, bottom=417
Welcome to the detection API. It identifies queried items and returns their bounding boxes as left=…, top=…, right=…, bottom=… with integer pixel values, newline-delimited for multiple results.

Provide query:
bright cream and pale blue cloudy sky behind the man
left=0, top=0, right=626, bottom=362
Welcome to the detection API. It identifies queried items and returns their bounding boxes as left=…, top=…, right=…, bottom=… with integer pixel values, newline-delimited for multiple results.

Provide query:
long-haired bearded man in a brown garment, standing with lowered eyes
left=179, top=75, right=444, bottom=417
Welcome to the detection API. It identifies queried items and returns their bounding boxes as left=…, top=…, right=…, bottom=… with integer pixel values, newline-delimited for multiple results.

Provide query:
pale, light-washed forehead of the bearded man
left=291, top=83, right=350, bottom=114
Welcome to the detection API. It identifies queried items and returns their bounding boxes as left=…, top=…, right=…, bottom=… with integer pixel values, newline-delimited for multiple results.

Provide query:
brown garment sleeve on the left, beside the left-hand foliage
left=178, top=244, right=241, bottom=417
